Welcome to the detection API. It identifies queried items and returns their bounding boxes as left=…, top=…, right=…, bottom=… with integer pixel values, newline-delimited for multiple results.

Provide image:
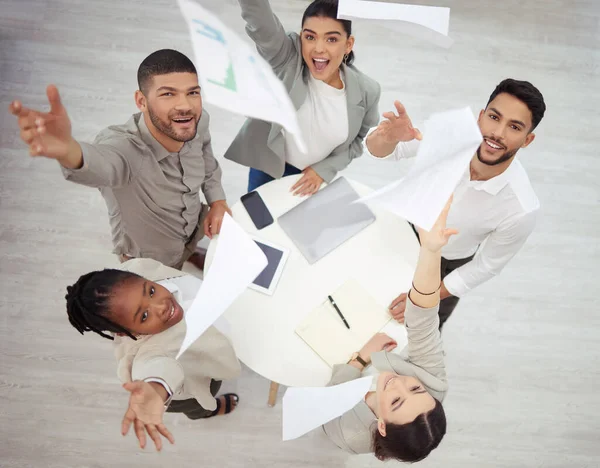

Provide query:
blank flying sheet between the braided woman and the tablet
left=177, top=214, right=267, bottom=359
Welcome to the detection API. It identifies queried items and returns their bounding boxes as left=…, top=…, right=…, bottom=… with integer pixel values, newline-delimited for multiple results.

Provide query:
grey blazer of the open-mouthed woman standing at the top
left=225, top=0, right=381, bottom=182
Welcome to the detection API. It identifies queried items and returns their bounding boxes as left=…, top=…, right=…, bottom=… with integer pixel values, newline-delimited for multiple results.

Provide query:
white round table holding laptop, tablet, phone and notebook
left=214, top=176, right=419, bottom=387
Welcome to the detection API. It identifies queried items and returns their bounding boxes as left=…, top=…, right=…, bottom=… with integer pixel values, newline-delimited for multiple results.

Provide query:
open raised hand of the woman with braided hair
left=121, top=381, right=175, bottom=451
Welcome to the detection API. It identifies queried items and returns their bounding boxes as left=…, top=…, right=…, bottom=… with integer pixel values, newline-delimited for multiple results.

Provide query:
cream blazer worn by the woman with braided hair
left=114, top=258, right=241, bottom=410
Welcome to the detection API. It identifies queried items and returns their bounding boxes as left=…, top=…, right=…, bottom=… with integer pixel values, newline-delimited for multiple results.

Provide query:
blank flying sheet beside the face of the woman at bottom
left=283, top=376, right=375, bottom=440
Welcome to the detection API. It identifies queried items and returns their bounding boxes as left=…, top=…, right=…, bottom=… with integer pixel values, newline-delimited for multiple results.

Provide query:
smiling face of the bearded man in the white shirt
left=477, top=93, right=535, bottom=166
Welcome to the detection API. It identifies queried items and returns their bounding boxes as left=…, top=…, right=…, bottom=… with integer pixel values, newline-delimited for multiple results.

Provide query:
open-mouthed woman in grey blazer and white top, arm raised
left=225, top=0, right=381, bottom=195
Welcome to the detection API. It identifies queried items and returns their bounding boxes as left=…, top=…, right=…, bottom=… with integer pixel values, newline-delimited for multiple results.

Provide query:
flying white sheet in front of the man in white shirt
left=358, top=107, right=483, bottom=231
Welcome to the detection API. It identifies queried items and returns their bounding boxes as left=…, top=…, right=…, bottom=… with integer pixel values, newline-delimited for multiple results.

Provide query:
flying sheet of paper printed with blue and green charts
left=178, top=0, right=307, bottom=152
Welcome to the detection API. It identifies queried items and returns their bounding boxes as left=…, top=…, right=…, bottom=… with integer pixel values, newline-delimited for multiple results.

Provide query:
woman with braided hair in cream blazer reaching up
left=65, top=259, right=240, bottom=450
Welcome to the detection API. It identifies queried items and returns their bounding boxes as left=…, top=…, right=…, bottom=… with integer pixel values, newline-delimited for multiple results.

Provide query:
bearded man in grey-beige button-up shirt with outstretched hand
left=10, top=49, right=230, bottom=269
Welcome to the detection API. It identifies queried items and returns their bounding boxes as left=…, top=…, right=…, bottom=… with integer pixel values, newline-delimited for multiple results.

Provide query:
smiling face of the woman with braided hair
left=109, top=277, right=183, bottom=335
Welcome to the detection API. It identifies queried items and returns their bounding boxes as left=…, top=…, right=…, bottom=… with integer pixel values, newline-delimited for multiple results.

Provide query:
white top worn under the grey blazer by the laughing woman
left=285, top=72, right=348, bottom=170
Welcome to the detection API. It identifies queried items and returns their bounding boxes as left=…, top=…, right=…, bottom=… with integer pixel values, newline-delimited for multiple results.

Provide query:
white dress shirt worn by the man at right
left=367, top=140, right=540, bottom=297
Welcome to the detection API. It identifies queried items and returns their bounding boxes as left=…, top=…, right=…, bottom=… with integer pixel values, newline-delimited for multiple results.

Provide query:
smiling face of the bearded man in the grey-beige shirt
left=136, top=73, right=202, bottom=146
